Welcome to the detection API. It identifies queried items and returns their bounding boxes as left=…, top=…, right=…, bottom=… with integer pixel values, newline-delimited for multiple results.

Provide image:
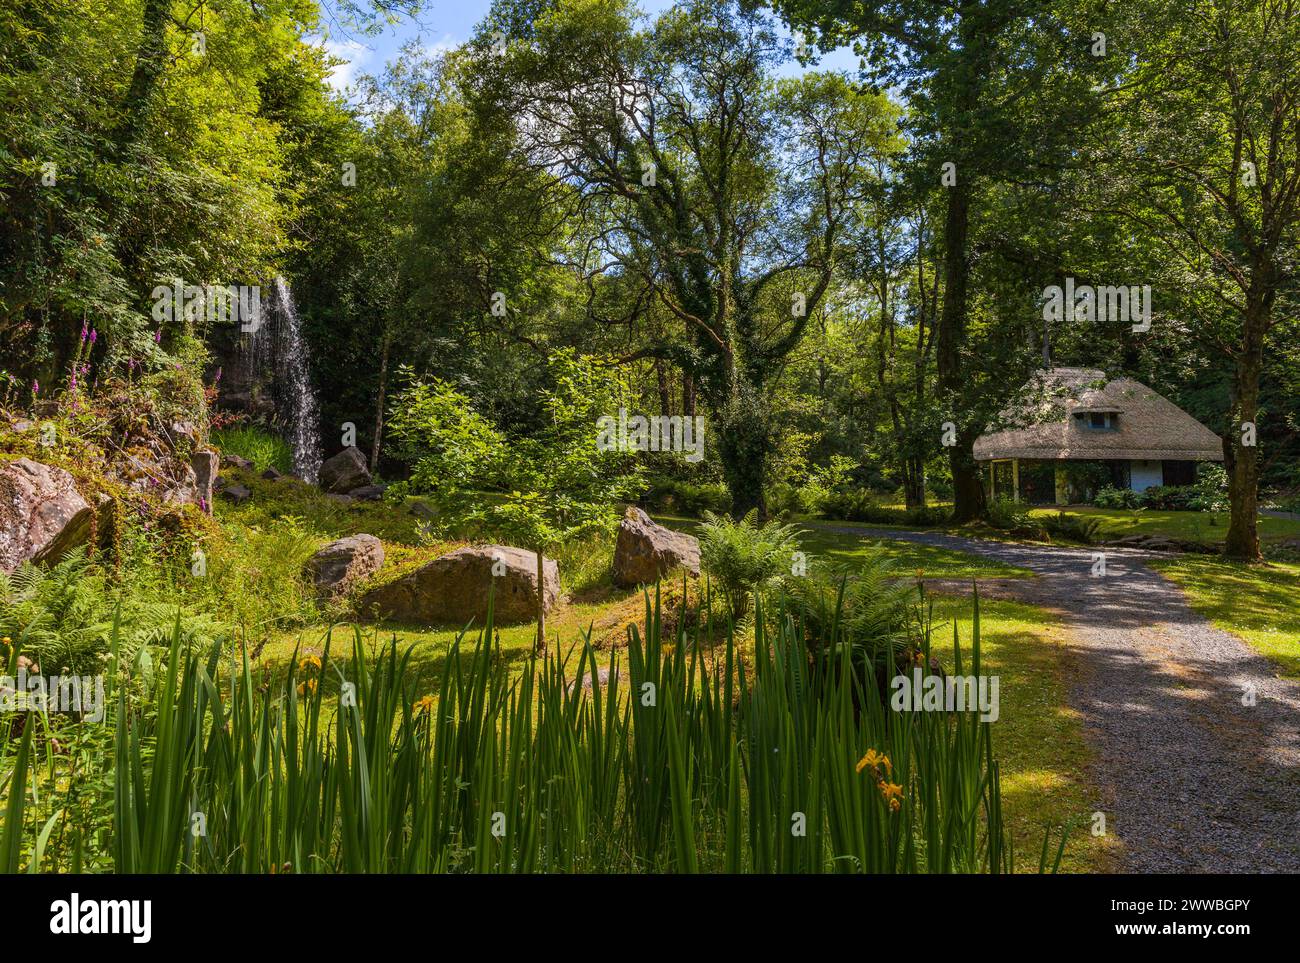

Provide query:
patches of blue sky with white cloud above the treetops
left=314, top=0, right=858, bottom=90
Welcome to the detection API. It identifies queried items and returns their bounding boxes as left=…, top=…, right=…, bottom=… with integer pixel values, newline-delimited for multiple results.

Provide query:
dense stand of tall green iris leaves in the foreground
left=0, top=584, right=1065, bottom=873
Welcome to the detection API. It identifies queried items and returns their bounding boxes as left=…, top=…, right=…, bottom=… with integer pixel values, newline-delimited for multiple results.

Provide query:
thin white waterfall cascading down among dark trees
left=241, top=278, right=321, bottom=483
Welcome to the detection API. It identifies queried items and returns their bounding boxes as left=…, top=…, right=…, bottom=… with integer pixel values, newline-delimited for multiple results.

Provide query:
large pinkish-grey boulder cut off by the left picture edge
left=0, top=457, right=95, bottom=572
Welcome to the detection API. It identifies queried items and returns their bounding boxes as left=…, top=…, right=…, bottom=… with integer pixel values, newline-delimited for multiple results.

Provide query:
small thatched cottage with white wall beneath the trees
left=975, top=368, right=1223, bottom=504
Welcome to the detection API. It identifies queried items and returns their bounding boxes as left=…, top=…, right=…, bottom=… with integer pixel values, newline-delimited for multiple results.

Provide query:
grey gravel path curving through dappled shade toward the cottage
left=818, top=525, right=1300, bottom=873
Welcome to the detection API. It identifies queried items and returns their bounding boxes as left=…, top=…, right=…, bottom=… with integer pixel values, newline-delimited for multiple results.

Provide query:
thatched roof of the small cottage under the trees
left=975, top=368, right=1223, bottom=461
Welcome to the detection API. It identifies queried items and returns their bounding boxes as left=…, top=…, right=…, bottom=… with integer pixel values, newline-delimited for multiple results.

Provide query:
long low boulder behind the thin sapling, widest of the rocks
left=360, top=545, right=560, bottom=625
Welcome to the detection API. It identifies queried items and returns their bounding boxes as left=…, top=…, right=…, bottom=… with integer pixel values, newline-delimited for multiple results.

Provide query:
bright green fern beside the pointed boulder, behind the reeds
left=697, top=511, right=800, bottom=621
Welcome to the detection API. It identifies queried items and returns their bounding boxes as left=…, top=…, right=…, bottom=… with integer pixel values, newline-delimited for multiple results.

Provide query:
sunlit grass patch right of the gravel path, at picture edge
left=1153, top=555, right=1300, bottom=678
